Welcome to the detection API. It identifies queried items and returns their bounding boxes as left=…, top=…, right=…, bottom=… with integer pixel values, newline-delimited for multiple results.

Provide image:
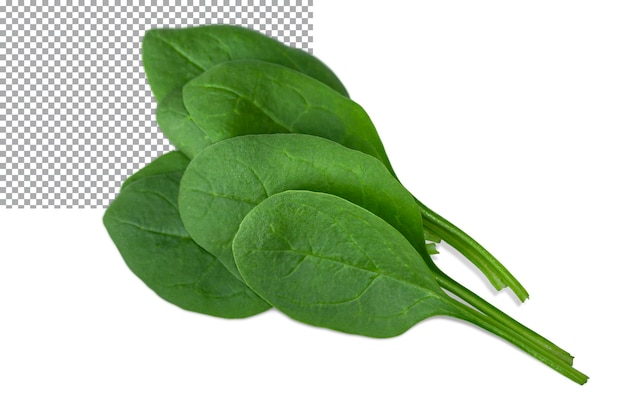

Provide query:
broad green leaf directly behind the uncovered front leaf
left=179, top=134, right=426, bottom=274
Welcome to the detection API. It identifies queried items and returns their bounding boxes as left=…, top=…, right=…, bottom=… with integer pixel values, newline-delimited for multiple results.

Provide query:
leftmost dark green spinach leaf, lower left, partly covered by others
left=103, top=152, right=270, bottom=318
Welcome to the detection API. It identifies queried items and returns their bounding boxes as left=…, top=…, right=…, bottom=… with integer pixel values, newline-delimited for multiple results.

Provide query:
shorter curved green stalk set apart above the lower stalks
left=416, top=199, right=528, bottom=301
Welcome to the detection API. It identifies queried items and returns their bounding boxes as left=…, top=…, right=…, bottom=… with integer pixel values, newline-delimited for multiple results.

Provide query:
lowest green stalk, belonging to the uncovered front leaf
left=451, top=299, right=589, bottom=385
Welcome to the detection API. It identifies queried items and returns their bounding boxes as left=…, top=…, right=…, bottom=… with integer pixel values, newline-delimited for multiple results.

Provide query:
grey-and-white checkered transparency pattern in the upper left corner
left=0, top=0, right=312, bottom=208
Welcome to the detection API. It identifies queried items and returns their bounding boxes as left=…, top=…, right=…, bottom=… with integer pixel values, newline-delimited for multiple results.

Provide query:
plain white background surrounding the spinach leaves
left=0, top=0, right=626, bottom=416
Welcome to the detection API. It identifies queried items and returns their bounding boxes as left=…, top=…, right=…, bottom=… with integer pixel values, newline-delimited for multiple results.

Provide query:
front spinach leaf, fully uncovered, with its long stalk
left=233, top=190, right=587, bottom=384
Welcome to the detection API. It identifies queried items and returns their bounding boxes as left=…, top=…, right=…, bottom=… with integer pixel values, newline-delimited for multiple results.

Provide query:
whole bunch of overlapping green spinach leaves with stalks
left=103, top=25, right=587, bottom=384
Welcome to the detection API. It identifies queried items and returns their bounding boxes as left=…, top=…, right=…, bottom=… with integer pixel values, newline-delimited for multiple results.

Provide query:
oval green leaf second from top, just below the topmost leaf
left=178, top=60, right=393, bottom=172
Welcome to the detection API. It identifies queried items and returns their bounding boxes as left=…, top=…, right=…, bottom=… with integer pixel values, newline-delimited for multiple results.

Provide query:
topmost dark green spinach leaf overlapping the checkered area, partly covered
left=142, top=25, right=348, bottom=101
